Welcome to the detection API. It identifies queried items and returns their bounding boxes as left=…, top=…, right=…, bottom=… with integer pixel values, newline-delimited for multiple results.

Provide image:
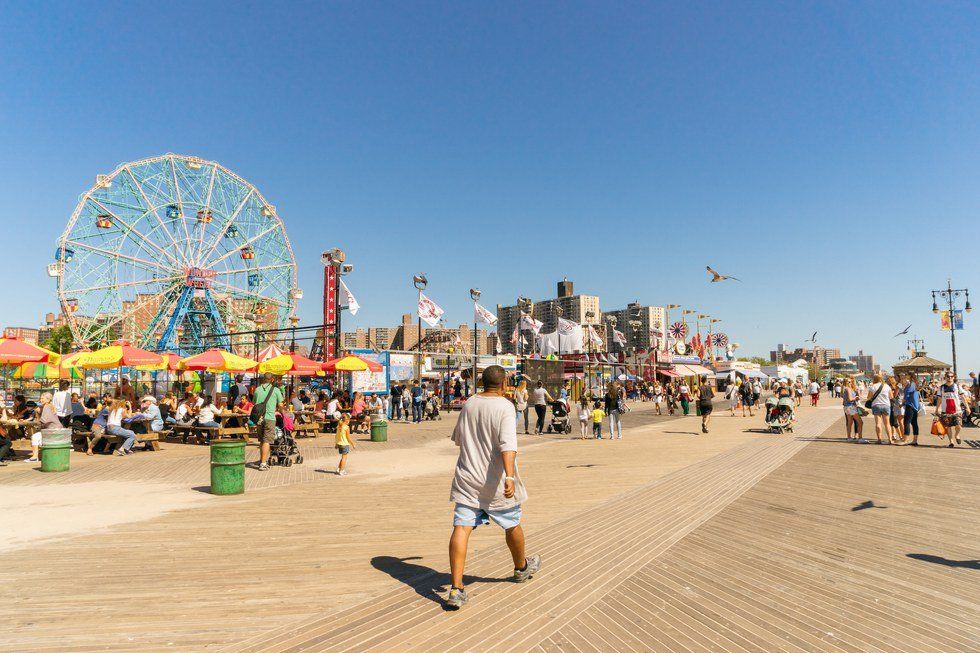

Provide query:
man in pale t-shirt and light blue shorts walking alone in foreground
left=446, top=365, right=541, bottom=610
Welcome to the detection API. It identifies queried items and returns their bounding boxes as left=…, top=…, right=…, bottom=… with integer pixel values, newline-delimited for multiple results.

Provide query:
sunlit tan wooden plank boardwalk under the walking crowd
left=0, top=400, right=980, bottom=653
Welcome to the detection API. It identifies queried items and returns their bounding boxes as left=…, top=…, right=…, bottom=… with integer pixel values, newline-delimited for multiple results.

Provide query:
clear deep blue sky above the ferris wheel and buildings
left=0, top=2, right=980, bottom=372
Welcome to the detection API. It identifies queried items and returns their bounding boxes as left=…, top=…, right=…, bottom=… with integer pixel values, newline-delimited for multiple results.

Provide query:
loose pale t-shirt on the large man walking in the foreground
left=449, top=394, right=527, bottom=510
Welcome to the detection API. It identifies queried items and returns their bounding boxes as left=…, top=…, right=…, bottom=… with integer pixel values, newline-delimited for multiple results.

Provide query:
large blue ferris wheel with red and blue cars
left=48, top=154, right=302, bottom=353
